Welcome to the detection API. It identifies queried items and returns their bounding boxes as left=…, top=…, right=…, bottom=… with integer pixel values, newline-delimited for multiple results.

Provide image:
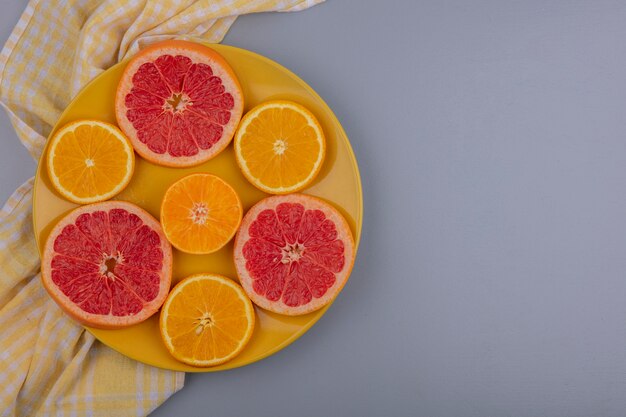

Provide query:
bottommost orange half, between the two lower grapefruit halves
left=159, top=274, right=254, bottom=366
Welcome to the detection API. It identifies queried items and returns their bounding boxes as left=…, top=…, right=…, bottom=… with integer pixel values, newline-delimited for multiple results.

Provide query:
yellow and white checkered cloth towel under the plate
left=0, top=0, right=323, bottom=417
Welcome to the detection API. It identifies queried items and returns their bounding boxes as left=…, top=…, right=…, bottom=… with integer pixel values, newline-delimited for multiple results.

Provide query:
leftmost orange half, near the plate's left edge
left=47, top=120, right=135, bottom=204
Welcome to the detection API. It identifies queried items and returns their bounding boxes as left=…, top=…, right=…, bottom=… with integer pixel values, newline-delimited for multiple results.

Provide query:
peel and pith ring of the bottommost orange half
left=159, top=273, right=255, bottom=367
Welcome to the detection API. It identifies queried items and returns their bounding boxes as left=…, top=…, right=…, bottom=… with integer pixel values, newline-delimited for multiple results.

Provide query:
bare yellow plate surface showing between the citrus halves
left=33, top=45, right=363, bottom=372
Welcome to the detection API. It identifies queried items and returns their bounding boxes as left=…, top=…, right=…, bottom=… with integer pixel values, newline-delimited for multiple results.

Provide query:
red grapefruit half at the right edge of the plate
left=234, top=194, right=355, bottom=315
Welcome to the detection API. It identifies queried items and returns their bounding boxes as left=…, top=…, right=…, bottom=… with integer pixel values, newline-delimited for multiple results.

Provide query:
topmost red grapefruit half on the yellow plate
left=115, top=40, right=243, bottom=167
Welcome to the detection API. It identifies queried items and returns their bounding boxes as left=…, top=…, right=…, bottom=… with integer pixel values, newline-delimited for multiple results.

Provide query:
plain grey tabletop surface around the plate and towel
left=0, top=0, right=626, bottom=417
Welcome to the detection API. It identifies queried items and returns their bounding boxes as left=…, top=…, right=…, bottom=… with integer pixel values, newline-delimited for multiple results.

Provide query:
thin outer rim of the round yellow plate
left=32, top=39, right=363, bottom=373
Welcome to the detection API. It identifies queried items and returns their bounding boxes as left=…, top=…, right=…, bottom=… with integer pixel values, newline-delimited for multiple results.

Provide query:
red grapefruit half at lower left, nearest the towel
left=41, top=201, right=172, bottom=328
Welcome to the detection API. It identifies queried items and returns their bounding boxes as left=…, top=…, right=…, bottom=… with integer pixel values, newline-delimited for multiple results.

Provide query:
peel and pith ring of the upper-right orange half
left=233, top=100, right=326, bottom=195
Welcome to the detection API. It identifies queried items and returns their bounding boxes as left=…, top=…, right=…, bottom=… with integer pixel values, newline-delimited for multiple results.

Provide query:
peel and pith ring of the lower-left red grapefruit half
left=41, top=201, right=172, bottom=329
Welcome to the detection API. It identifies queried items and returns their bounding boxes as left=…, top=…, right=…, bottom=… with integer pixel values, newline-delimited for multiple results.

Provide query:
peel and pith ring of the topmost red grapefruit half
left=115, top=40, right=244, bottom=167
